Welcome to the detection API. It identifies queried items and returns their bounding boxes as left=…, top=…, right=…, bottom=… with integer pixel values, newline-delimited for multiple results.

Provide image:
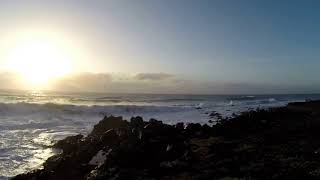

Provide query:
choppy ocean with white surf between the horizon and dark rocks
left=0, top=91, right=320, bottom=179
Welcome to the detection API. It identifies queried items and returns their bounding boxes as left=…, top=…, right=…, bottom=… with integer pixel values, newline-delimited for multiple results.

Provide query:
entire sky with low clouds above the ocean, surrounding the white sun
left=0, top=0, right=320, bottom=94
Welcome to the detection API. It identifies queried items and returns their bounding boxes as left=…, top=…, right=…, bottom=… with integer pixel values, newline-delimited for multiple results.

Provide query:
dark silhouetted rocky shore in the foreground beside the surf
left=13, top=101, right=320, bottom=180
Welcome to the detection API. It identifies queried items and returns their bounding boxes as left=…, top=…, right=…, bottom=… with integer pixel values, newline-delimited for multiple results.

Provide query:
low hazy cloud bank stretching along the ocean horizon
left=0, top=72, right=320, bottom=94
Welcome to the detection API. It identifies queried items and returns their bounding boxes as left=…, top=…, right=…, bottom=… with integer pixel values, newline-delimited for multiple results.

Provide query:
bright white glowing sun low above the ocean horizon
left=7, top=41, right=71, bottom=86
